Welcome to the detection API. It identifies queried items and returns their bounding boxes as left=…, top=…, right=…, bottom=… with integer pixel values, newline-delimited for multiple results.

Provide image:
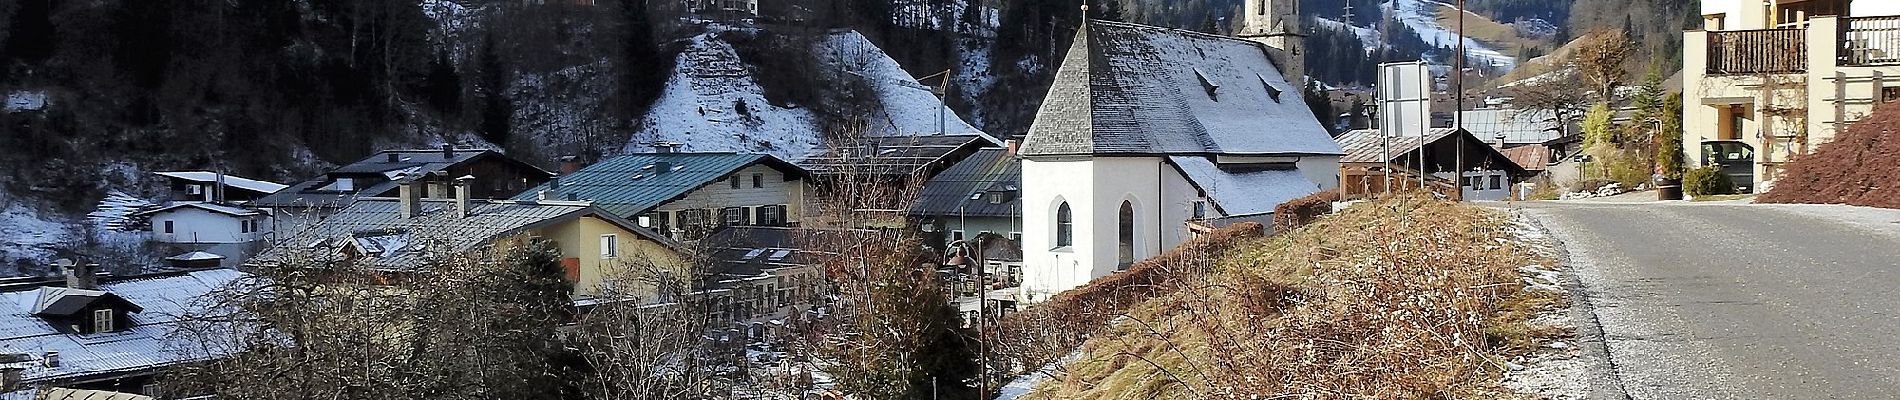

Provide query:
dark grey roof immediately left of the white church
left=910, top=148, right=1022, bottom=216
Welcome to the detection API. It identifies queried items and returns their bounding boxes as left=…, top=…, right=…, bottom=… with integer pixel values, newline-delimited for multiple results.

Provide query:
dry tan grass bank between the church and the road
left=1030, top=195, right=1566, bottom=398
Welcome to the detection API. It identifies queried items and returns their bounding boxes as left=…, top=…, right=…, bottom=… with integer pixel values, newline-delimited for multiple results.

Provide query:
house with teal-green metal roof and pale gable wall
left=515, top=144, right=809, bottom=241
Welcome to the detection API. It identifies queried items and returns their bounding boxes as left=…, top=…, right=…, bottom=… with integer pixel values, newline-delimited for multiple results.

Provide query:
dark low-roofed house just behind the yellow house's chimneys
left=249, top=144, right=553, bottom=231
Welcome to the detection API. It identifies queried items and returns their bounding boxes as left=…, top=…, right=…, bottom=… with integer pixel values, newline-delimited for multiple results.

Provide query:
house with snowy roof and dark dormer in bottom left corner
left=0, top=265, right=247, bottom=398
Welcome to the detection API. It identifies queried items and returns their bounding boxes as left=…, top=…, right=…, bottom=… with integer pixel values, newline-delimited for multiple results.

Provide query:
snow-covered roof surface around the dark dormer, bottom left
left=0, top=269, right=249, bottom=383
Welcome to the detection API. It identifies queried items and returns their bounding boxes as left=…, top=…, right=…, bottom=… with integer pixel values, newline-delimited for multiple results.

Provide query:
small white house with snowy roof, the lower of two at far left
left=139, top=201, right=270, bottom=243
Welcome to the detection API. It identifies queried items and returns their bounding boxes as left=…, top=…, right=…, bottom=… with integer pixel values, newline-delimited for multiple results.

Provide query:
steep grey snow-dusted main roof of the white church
left=1022, top=21, right=1340, bottom=157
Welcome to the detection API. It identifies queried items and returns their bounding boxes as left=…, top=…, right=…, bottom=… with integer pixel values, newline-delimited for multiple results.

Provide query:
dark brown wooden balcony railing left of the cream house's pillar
left=1708, top=28, right=1807, bottom=74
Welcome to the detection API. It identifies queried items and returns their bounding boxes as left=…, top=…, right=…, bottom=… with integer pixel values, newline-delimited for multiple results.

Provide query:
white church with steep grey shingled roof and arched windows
left=1020, top=0, right=1341, bottom=303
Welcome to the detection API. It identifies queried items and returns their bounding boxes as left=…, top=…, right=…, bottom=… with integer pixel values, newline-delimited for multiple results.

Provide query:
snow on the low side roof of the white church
left=1169, top=155, right=1319, bottom=216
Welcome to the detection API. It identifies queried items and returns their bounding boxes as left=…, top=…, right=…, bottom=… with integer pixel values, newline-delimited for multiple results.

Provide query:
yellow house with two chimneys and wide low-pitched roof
left=247, top=178, right=684, bottom=301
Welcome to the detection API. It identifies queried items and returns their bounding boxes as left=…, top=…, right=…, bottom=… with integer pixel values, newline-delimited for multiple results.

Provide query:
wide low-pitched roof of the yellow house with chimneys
left=245, top=197, right=676, bottom=271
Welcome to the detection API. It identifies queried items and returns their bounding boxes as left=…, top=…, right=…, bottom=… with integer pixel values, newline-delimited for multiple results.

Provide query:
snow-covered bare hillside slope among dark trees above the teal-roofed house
left=625, top=32, right=979, bottom=161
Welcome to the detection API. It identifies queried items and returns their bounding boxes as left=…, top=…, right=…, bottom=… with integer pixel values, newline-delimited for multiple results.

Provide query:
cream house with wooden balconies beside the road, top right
left=1682, top=0, right=1900, bottom=191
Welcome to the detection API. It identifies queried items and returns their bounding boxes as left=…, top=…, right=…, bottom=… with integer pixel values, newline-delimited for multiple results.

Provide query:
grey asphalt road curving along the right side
left=1511, top=201, right=1900, bottom=398
